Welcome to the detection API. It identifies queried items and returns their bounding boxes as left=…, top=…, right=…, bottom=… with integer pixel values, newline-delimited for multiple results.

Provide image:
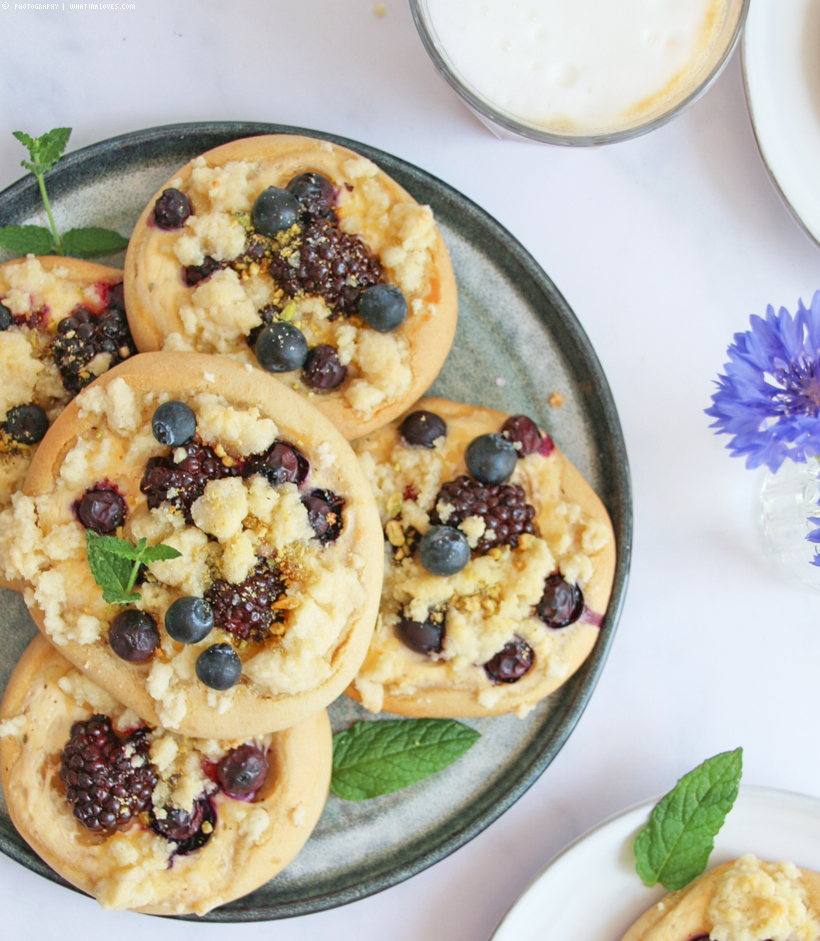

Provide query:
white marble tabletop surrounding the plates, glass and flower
left=0, top=0, right=820, bottom=941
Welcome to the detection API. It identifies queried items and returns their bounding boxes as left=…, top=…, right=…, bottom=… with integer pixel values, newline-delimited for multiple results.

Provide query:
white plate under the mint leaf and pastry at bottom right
left=492, top=787, right=820, bottom=941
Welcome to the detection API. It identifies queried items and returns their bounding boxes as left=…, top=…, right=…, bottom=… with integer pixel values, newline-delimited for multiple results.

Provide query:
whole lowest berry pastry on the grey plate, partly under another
left=0, top=637, right=333, bottom=915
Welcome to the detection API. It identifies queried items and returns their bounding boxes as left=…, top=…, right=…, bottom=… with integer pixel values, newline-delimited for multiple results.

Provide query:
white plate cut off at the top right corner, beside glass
left=742, top=0, right=820, bottom=243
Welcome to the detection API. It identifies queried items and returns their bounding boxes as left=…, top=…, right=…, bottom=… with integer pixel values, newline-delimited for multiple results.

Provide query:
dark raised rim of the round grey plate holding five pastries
left=0, top=121, right=632, bottom=922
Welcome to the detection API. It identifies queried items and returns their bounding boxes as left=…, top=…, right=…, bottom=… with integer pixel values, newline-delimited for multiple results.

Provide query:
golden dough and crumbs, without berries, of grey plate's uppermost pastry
left=125, top=135, right=457, bottom=439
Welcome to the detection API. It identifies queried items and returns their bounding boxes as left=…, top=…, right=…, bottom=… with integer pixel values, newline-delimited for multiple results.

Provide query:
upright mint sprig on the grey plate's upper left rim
left=0, top=127, right=128, bottom=258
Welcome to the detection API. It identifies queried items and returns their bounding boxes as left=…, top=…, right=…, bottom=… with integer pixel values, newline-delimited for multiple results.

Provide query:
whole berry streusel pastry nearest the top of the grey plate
left=125, top=134, right=457, bottom=439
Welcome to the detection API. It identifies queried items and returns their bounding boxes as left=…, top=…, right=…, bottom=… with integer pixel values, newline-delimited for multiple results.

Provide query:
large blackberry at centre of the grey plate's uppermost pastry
left=270, top=219, right=382, bottom=319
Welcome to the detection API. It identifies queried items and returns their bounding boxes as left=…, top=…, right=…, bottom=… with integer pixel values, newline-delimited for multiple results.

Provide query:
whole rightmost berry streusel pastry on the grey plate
left=348, top=399, right=615, bottom=717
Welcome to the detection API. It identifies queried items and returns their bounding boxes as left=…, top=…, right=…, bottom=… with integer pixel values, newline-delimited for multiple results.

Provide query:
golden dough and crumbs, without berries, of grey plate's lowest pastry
left=0, top=637, right=332, bottom=915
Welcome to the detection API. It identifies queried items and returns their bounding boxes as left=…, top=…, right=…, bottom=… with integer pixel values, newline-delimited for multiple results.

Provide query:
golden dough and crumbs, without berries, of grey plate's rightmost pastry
left=347, top=399, right=615, bottom=717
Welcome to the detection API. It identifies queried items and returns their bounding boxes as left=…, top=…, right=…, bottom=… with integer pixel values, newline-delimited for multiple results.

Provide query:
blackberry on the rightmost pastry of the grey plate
left=430, top=474, right=535, bottom=552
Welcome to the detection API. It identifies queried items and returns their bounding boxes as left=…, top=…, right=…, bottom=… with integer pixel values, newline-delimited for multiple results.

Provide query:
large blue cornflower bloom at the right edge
left=706, top=291, right=820, bottom=474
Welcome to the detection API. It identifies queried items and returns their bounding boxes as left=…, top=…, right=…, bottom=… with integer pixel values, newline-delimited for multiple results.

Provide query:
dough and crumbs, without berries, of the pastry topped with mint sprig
left=3, top=353, right=382, bottom=739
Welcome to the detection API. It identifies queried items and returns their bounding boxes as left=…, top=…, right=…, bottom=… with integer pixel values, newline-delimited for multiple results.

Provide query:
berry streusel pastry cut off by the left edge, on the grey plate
left=0, top=255, right=136, bottom=590
